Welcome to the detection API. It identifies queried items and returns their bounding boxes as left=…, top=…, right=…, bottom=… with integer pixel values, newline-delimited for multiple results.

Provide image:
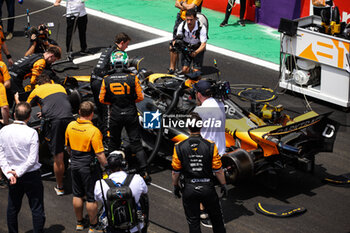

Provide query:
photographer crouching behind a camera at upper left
left=24, top=24, right=58, bottom=56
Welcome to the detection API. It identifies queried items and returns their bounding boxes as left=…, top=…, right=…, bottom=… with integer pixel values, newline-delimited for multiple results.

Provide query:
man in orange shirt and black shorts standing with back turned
left=66, top=101, right=107, bottom=232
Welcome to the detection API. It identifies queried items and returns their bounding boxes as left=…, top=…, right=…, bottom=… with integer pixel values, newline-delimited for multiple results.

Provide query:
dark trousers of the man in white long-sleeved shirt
left=7, top=170, right=46, bottom=233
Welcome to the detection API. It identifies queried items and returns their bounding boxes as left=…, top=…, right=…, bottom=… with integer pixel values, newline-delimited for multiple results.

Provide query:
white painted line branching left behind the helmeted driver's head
left=73, top=37, right=172, bottom=64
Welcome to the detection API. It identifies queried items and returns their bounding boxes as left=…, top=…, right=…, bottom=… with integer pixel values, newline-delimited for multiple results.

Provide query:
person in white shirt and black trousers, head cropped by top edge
left=54, top=0, right=90, bottom=56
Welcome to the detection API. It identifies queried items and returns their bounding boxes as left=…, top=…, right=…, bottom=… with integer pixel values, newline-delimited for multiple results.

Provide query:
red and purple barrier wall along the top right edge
left=203, top=0, right=350, bottom=28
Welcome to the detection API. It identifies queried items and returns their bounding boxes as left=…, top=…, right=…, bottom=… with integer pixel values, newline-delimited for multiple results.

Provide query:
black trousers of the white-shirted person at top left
left=66, top=15, right=88, bottom=52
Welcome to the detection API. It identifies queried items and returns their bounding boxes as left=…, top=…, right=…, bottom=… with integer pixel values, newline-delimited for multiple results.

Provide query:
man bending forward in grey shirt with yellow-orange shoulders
left=20, top=74, right=74, bottom=195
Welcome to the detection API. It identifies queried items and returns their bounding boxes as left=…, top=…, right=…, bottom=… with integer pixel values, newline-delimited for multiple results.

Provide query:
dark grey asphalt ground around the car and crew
left=0, top=0, right=350, bottom=233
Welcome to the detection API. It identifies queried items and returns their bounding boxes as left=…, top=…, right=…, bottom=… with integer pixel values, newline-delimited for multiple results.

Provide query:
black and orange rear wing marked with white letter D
left=249, top=111, right=339, bottom=157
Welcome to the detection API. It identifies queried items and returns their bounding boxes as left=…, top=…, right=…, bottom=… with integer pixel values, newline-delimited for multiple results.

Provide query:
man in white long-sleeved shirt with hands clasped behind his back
left=0, top=102, right=45, bottom=233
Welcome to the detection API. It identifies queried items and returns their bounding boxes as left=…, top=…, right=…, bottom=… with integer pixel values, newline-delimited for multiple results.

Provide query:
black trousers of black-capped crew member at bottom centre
left=182, top=183, right=226, bottom=233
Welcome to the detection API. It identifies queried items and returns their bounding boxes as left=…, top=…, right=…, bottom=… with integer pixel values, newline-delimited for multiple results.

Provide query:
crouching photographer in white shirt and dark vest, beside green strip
left=173, top=9, right=208, bottom=74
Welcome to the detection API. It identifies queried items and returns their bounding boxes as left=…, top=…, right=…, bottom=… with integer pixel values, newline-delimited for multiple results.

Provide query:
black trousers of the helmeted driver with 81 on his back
left=108, top=115, right=147, bottom=170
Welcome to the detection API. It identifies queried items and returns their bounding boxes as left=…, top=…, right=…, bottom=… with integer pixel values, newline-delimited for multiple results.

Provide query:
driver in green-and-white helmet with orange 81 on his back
left=100, top=50, right=151, bottom=184
